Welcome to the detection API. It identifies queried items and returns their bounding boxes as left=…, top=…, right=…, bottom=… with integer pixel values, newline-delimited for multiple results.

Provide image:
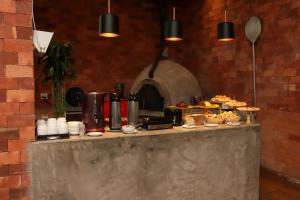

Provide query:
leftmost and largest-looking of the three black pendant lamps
left=99, top=0, right=119, bottom=38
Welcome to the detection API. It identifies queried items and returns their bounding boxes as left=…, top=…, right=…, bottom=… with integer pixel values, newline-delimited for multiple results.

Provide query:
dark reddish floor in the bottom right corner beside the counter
left=260, top=169, right=300, bottom=200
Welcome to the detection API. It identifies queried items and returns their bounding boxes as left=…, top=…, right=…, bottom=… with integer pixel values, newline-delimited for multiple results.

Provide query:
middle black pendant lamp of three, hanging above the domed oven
left=164, top=7, right=183, bottom=42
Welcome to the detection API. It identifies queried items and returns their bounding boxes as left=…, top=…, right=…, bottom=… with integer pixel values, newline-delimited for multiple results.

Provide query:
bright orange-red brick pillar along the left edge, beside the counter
left=0, top=0, right=34, bottom=200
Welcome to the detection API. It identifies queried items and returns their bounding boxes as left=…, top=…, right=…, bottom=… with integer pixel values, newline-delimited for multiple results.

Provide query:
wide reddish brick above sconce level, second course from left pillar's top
left=4, top=13, right=32, bottom=27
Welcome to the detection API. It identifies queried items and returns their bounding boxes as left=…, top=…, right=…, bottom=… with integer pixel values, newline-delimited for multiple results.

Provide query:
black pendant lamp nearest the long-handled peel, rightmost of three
left=218, top=0, right=234, bottom=42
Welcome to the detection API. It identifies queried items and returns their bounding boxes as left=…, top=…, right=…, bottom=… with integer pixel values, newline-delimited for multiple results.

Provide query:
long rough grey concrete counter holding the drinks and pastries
left=30, top=125, right=260, bottom=200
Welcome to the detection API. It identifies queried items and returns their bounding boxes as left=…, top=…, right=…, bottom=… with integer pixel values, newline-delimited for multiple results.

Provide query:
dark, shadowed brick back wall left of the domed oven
left=34, top=0, right=160, bottom=108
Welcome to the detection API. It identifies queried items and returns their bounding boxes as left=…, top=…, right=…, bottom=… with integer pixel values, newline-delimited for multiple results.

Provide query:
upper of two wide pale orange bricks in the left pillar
left=5, top=65, right=33, bottom=78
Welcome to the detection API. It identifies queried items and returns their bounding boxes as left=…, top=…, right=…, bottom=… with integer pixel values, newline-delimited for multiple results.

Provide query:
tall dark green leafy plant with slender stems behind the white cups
left=39, top=42, right=75, bottom=117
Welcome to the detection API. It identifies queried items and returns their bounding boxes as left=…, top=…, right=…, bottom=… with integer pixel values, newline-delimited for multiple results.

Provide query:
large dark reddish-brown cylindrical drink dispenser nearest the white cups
left=82, top=91, right=107, bottom=132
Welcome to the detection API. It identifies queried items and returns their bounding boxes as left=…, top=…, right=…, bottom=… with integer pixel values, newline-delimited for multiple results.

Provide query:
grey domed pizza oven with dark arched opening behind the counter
left=130, top=59, right=202, bottom=111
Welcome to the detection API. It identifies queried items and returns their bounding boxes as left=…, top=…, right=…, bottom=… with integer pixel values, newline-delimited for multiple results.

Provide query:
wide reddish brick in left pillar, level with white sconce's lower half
left=4, top=39, right=33, bottom=52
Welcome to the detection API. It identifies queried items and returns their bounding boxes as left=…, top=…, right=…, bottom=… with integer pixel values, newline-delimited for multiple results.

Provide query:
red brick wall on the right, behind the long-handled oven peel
left=171, top=0, right=300, bottom=179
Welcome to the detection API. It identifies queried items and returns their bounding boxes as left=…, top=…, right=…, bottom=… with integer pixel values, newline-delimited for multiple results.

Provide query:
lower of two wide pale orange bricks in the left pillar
left=6, top=90, right=34, bottom=102
